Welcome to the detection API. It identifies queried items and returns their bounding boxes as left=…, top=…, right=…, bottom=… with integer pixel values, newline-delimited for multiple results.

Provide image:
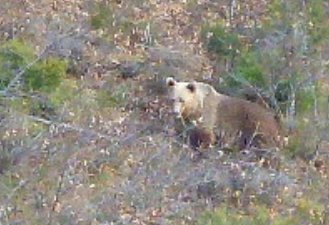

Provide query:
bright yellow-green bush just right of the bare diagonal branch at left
left=26, top=58, right=68, bottom=92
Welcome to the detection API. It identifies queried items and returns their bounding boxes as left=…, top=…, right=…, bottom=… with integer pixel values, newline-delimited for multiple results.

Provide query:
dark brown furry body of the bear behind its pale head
left=203, top=93, right=280, bottom=149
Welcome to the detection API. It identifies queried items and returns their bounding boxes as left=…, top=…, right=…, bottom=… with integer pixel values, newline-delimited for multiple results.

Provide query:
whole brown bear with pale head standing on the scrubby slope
left=166, top=77, right=280, bottom=149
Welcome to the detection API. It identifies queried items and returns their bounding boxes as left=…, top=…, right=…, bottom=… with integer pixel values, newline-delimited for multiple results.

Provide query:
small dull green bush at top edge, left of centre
left=90, top=3, right=114, bottom=29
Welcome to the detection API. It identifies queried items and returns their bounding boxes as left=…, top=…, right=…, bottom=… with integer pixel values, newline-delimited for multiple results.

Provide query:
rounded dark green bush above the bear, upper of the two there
left=201, top=24, right=241, bottom=57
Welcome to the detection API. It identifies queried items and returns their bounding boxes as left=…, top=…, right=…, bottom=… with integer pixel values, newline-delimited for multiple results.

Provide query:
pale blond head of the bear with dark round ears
left=166, top=77, right=204, bottom=120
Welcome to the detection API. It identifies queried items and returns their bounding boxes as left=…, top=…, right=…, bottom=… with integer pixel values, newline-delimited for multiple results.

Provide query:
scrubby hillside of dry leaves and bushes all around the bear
left=0, top=0, right=329, bottom=225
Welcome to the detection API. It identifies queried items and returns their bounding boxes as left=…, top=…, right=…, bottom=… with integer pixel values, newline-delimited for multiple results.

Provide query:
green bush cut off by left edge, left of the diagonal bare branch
left=0, top=39, right=35, bottom=90
